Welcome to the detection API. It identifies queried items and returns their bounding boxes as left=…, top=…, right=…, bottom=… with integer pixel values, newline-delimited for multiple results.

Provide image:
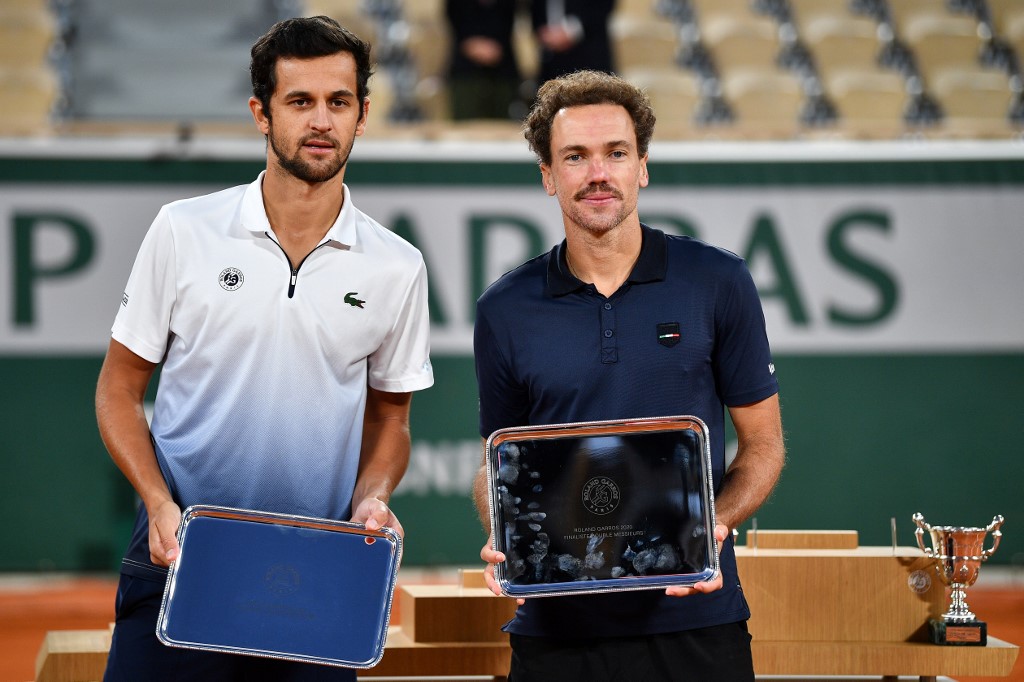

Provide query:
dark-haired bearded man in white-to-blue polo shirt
left=96, top=16, right=433, bottom=682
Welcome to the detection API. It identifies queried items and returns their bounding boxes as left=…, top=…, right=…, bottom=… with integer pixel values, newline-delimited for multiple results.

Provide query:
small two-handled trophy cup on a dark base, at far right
left=913, top=512, right=1002, bottom=646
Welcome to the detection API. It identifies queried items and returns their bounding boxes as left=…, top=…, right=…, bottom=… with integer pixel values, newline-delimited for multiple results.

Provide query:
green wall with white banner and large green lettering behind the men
left=0, top=142, right=1024, bottom=571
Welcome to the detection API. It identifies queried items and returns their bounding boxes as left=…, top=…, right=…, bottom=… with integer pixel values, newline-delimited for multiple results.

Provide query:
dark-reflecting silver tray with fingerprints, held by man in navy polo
left=486, top=416, right=719, bottom=597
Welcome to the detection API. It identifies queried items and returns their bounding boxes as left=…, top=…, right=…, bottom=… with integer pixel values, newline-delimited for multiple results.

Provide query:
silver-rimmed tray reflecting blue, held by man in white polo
left=157, top=505, right=401, bottom=668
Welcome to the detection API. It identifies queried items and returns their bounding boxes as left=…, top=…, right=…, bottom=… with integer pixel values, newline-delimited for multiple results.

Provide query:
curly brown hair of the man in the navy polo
left=523, top=71, right=654, bottom=166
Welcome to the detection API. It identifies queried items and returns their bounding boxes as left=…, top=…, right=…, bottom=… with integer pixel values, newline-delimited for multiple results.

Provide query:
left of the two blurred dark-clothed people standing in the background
left=444, top=0, right=521, bottom=121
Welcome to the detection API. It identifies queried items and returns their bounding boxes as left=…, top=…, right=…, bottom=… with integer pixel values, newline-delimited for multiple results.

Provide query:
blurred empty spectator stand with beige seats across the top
left=0, top=0, right=1024, bottom=139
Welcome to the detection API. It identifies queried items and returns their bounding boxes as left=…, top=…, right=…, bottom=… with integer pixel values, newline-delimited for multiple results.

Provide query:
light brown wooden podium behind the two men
left=36, top=534, right=1019, bottom=682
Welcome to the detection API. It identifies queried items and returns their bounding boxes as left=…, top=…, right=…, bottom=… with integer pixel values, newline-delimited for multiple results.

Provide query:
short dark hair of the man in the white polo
left=249, top=16, right=373, bottom=119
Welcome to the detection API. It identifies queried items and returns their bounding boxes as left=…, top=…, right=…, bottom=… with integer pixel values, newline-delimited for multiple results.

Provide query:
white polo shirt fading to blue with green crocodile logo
left=112, top=173, right=433, bottom=519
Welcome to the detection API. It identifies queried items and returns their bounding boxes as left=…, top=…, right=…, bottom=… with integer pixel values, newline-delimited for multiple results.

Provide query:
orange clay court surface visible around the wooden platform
left=0, top=569, right=1024, bottom=682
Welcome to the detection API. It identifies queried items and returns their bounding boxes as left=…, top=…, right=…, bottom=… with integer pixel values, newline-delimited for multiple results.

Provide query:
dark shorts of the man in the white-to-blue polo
left=103, top=573, right=355, bottom=682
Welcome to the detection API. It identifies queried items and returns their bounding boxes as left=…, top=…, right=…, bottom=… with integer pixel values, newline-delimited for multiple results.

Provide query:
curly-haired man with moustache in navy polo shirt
left=474, top=72, right=785, bottom=682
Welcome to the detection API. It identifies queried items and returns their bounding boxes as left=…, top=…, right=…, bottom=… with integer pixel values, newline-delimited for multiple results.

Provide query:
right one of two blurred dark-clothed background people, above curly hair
left=530, top=0, right=615, bottom=85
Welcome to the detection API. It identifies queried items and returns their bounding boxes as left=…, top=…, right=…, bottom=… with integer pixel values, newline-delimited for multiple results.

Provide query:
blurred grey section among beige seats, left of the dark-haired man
left=69, top=0, right=282, bottom=122
